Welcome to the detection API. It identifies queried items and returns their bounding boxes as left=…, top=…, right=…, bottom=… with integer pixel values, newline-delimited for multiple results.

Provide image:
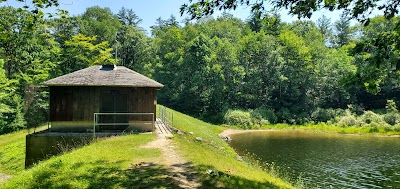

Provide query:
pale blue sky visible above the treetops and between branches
left=0, top=0, right=360, bottom=32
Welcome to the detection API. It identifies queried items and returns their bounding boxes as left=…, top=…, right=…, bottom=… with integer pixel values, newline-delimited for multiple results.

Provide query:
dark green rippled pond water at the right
left=230, top=131, right=400, bottom=188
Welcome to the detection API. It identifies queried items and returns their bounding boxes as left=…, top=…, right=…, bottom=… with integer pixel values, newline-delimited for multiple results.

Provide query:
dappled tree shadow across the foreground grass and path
left=18, top=161, right=277, bottom=189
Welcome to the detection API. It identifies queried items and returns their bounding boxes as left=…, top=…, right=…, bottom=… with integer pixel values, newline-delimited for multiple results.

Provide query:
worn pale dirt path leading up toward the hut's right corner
left=142, top=120, right=201, bottom=188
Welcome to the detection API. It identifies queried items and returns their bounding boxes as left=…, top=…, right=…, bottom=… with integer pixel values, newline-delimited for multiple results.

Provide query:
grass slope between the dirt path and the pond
left=161, top=106, right=293, bottom=188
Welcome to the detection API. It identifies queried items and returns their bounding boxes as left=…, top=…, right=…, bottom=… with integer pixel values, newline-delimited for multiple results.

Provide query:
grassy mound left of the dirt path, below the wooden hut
left=1, top=134, right=166, bottom=188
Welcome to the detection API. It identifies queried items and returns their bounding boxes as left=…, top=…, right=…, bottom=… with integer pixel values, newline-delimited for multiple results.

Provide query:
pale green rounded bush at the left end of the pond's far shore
left=224, top=110, right=253, bottom=128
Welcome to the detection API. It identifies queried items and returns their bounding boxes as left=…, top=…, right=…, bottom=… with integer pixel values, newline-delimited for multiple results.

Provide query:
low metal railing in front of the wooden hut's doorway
left=93, top=113, right=155, bottom=137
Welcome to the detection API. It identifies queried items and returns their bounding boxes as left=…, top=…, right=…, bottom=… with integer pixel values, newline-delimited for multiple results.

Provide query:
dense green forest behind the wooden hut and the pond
left=0, top=7, right=400, bottom=134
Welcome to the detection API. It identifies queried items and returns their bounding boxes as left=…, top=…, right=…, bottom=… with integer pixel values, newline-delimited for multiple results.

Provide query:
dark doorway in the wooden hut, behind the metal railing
left=99, top=91, right=128, bottom=131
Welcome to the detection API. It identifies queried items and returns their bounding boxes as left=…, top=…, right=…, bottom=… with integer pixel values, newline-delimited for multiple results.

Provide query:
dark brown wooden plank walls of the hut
left=50, top=86, right=157, bottom=132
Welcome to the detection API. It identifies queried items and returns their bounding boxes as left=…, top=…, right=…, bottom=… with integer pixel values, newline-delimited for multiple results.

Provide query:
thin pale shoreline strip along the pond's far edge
left=218, top=128, right=400, bottom=139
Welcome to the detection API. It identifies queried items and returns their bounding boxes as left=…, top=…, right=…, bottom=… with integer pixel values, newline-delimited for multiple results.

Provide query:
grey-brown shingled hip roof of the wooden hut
left=42, top=65, right=164, bottom=88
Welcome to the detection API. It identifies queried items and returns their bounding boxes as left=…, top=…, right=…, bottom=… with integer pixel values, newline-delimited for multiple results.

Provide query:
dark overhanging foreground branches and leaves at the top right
left=180, top=0, right=400, bottom=92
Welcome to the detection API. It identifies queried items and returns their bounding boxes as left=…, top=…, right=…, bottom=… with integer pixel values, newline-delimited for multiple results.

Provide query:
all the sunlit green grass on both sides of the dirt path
left=0, top=106, right=292, bottom=188
